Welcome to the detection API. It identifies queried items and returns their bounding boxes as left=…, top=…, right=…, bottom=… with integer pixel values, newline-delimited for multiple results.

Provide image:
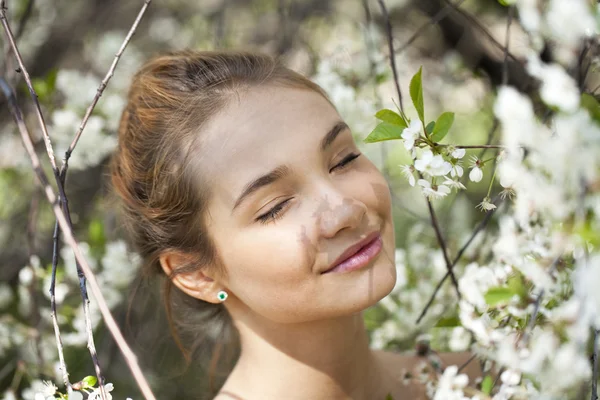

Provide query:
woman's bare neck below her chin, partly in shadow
left=224, top=313, right=381, bottom=400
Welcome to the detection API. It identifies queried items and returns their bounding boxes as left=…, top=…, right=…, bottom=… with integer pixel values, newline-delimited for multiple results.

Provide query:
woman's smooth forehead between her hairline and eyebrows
left=199, top=86, right=340, bottom=205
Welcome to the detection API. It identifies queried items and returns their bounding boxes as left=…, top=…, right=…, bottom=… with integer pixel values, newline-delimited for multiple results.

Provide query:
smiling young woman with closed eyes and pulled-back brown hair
left=111, top=51, right=478, bottom=400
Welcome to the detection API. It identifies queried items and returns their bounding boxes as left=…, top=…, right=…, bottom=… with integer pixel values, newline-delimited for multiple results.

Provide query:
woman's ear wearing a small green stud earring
left=159, top=252, right=224, bottom=303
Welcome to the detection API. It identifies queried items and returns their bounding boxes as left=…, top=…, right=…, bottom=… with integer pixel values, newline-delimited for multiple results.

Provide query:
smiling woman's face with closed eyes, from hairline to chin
left=199, top=86, right=396, bottom=323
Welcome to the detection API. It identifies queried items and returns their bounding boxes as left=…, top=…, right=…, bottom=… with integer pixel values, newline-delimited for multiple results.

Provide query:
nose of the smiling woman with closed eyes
left=315, top=189, right=367, bottom=238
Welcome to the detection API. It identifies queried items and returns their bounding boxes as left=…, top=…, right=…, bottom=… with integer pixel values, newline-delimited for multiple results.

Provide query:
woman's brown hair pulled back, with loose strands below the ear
left=110, top=50, right=327, bottom=394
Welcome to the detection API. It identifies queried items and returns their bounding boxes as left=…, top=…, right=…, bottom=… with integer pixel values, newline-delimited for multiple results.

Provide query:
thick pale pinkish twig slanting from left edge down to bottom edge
left=0, top=79, right=155, bottom=400
